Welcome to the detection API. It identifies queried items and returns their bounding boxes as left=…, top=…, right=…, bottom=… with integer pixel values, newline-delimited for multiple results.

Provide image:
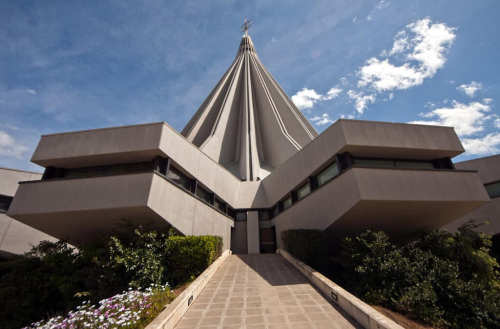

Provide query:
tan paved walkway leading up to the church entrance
left=176, top=254, right=362, bottom=329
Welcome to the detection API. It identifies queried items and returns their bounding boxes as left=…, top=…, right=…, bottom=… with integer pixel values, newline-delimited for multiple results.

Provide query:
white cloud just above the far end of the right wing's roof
left=410, top=101, right=491, bottom=136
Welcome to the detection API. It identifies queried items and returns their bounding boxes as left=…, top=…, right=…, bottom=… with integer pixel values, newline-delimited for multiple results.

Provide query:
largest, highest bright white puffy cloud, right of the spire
left=357, top=18, right=456, bottom=92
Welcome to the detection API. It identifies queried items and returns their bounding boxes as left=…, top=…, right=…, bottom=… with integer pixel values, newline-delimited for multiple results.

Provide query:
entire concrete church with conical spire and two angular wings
left=8, top=35, right=490, bottom=253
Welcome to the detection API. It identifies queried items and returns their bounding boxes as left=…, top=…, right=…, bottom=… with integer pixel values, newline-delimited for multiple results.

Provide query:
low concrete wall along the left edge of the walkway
left=146, top=250, right=231, bottom=329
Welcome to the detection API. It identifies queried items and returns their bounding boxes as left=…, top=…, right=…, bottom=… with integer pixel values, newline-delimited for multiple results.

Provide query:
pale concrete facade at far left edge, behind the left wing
left=0, top=168, right=57, bottom=259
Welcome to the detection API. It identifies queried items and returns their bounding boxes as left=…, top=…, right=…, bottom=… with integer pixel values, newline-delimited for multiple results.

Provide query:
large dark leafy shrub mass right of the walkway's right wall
left=333, top=223, right=500, bottom=328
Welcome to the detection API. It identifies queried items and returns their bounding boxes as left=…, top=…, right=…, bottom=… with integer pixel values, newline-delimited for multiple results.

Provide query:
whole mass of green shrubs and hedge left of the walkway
left=0, top=226, right=222, bottom=328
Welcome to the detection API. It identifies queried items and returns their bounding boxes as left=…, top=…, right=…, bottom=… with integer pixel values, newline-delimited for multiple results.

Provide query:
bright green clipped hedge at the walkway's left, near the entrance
left=165, top=235, right=223, bottom=285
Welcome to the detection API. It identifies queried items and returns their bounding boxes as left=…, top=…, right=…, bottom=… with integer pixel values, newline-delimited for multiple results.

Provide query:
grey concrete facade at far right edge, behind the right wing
left=443, top=155, right=500, bottom=235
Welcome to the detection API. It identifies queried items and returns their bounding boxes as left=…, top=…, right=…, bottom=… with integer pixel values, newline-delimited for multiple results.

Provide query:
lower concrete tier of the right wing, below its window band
left=272, top=168, right=489, bottom=247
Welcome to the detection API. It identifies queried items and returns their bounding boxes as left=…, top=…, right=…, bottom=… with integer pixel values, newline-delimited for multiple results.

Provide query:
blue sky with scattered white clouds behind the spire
left=0, top=0, right=500, bottom=171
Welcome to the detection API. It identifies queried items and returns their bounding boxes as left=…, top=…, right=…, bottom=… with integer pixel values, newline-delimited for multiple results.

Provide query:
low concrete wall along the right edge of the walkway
left=276, top=249, right=404, bottom=329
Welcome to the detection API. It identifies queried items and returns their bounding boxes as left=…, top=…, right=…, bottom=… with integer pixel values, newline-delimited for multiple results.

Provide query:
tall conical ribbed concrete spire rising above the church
left=182, top=35, right=318, bottom=180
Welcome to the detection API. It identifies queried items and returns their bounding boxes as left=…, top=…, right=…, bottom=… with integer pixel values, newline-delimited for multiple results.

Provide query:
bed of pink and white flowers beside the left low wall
left=23, top=284, right=173, bottom=329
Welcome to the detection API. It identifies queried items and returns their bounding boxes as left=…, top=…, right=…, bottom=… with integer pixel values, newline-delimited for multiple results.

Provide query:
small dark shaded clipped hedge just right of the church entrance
left=281, top=229, right=329, bottom=273
